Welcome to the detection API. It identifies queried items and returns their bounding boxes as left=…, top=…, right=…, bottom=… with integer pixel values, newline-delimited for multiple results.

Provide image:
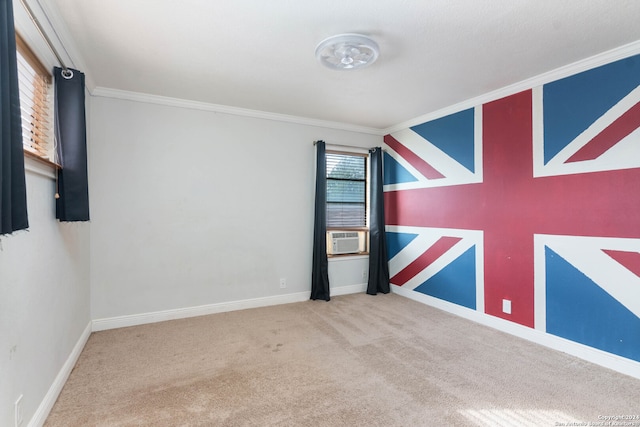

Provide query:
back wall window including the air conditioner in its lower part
left=326, top=151, right=368, bottom=255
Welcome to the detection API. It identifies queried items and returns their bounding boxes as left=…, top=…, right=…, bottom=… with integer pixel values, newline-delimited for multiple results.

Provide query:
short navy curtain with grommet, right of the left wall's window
left=53, top=67, right=89, bottom=221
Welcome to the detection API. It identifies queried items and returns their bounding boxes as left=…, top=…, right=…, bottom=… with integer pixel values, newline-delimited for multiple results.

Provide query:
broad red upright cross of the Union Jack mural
left=385, top=91, right=640, bottom=328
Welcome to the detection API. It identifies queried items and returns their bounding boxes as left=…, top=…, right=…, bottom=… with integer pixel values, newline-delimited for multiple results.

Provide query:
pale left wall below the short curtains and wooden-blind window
left=0, top=160, right=90, bottom=426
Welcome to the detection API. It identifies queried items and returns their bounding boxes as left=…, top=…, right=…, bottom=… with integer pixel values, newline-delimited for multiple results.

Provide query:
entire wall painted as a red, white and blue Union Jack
left=384, top=55, right=640, bottom=361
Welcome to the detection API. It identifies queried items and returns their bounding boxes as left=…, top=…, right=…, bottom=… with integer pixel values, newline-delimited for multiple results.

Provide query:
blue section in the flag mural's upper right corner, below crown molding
left=543, top=55, right=640, bottom=164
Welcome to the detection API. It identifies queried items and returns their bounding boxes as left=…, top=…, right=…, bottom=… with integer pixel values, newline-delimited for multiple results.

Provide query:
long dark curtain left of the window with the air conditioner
left=311, top=141, right=331, bottom=301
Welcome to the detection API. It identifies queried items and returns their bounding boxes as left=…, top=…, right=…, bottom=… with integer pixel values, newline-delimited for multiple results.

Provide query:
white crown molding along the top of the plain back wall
left=91, top=86, right=383, bottom=135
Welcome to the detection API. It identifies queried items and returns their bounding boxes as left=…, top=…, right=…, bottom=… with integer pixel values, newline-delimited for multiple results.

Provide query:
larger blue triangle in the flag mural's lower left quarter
left=415, top=246, right=476, bottom=310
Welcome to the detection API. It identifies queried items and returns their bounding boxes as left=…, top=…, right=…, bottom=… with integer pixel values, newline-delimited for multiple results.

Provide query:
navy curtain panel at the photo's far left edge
left=0, top=0, right=29, bottom=235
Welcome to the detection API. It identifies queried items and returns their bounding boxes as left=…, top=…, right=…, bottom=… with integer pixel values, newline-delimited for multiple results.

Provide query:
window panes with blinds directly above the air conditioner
left=326, top=152, right=367, bottom=229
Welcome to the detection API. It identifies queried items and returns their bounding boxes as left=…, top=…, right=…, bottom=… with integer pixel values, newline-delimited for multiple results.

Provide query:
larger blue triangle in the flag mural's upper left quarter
left=411, top=109, right=475, bottom=172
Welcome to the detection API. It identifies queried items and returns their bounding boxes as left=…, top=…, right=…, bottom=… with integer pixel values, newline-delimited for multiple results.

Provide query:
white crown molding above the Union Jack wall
left=382, top=40, right=640, bottom=135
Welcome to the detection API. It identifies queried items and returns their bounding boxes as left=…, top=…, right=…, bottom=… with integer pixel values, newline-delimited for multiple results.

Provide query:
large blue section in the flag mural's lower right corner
left=545, top=247, right=640, bottom=361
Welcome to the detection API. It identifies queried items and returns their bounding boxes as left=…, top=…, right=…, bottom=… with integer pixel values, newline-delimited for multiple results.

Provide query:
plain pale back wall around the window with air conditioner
left=90, top=97, right=382, bottom=319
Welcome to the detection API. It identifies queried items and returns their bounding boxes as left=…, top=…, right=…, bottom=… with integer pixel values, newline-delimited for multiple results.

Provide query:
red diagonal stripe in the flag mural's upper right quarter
left=565, top=102, right=640, bottom=163
